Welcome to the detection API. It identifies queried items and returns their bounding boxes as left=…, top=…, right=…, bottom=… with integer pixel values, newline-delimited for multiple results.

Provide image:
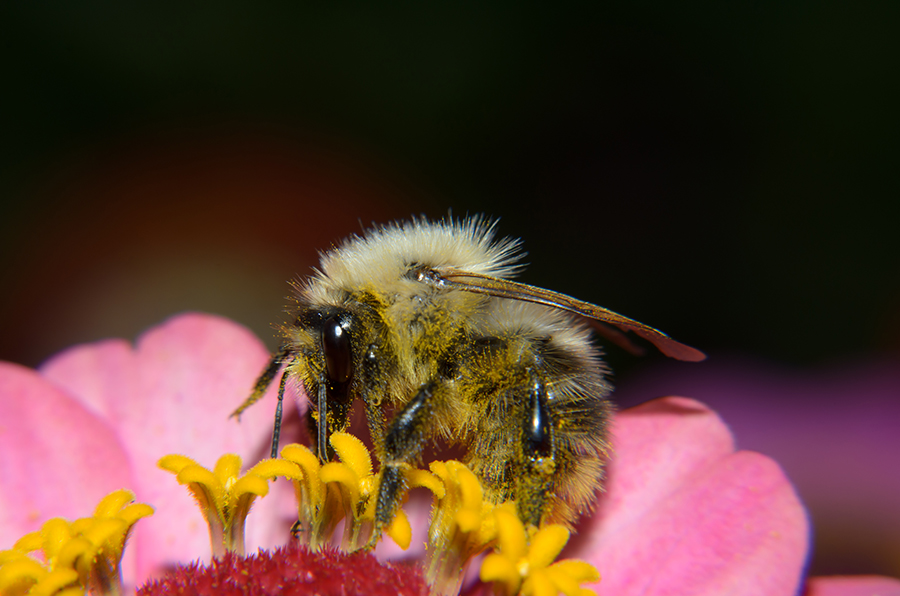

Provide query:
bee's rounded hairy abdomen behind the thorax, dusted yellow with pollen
left=459, top=305, right=611, bottom=523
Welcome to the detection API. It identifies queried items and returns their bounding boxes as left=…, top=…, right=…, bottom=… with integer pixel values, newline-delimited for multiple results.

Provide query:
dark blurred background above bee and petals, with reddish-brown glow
left=0, top=2, right=900, bottom=584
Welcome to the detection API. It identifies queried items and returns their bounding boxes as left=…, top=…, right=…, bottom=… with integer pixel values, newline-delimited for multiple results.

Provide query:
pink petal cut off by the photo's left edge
left=0, top=362, right=133, bottom=549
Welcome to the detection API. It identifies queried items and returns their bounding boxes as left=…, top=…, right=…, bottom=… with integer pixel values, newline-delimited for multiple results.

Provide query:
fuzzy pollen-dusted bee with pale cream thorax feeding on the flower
left=234, top=217, right=705, bottom=536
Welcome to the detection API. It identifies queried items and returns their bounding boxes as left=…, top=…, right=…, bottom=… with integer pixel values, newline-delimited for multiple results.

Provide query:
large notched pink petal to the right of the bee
left=567, top=397, right=808, bottom=595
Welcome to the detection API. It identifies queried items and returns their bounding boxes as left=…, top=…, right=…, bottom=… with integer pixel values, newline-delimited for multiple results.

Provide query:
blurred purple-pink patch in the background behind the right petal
left=617, top=354, right=900, bottom=576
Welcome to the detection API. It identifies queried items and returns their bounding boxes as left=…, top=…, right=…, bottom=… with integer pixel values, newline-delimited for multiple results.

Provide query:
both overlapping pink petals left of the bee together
left=0, top=314, right=295, bottom=586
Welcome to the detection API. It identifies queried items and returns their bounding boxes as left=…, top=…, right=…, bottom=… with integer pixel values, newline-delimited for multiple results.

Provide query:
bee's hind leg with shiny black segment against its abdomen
left=515, top=371, right=556, bottom=526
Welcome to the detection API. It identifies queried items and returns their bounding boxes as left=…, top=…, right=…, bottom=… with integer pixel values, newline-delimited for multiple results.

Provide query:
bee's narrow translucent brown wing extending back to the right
left=432, top=268, right=706, bottom=362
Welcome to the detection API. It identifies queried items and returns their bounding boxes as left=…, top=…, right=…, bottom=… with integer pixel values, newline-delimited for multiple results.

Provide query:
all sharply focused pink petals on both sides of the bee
left=0, top=314, right=900, bottom=596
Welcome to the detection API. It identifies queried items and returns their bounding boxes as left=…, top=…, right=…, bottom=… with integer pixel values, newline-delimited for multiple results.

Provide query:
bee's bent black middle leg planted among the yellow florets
left=372, top=383, right=435, bottom=542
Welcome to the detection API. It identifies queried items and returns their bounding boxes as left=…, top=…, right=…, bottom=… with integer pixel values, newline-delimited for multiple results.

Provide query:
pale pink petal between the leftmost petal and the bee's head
left=41, top=314, right=295, bottom=581
